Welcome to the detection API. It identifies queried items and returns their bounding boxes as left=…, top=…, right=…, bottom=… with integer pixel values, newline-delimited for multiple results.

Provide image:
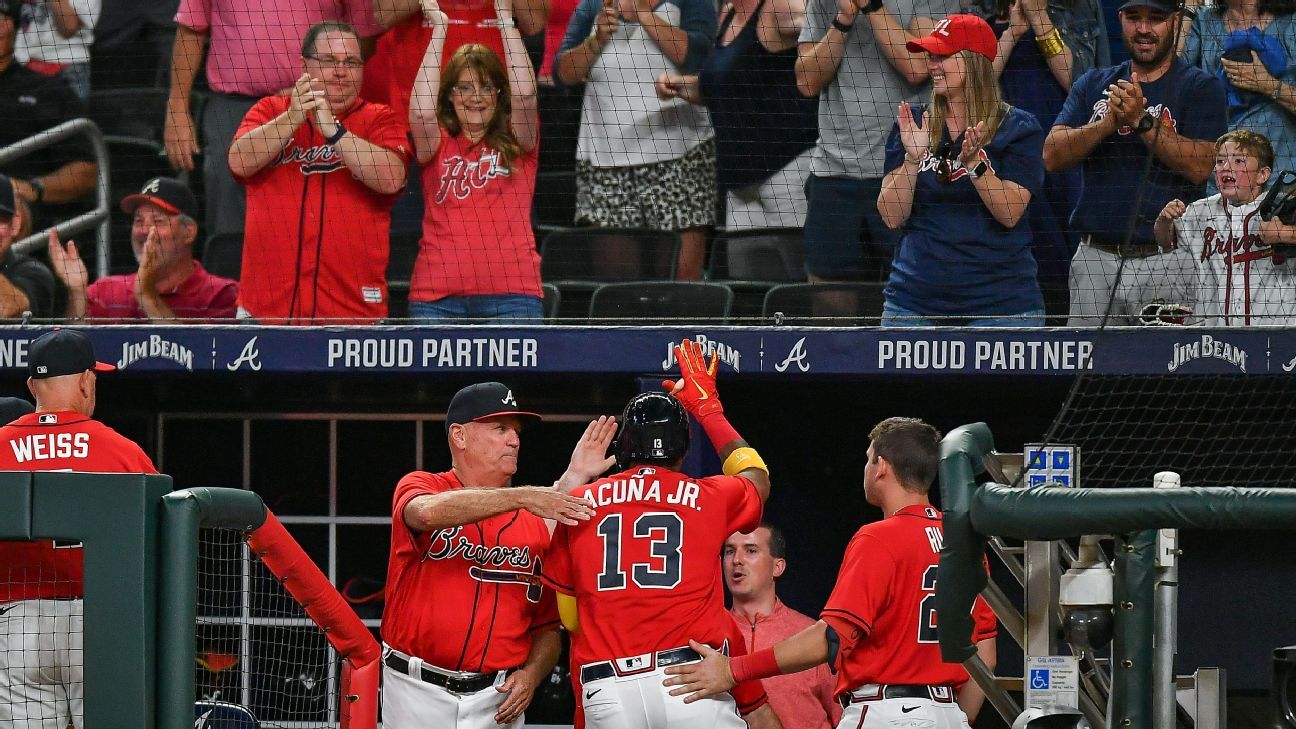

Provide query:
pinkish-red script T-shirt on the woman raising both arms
left=410, top=130, right=540, bottom=301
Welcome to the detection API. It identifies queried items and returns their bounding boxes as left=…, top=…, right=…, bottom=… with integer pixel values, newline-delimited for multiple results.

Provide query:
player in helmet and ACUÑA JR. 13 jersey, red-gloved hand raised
left=544, top=341, right=770, bottom=729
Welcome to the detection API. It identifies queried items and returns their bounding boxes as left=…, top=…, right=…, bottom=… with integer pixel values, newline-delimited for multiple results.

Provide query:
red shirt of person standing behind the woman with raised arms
left=360, top=0, right=510, bottom=119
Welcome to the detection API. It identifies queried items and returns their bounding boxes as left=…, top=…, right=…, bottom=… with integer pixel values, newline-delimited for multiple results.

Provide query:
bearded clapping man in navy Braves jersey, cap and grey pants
left=1045, top=0, right=1227, bottom=327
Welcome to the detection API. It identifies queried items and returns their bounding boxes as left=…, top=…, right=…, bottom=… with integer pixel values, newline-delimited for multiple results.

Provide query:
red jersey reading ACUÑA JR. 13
left=544, top=466, right=762, bottom=665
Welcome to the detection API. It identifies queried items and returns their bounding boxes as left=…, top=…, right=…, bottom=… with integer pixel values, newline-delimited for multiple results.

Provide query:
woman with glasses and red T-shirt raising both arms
left=410, top=0, right=543, bottom=323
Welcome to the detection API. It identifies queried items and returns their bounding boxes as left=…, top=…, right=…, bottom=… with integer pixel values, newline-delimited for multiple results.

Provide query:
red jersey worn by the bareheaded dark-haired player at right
left=819, top=505, right=997, bottom=695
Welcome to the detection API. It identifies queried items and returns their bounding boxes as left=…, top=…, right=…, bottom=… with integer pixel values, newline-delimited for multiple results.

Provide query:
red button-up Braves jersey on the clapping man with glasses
left=235, top=96, right=410, bottom=324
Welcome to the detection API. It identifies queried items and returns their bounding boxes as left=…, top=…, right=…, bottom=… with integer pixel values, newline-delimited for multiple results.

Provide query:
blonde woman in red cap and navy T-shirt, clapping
left=877, top=16, right=1045, bottom=327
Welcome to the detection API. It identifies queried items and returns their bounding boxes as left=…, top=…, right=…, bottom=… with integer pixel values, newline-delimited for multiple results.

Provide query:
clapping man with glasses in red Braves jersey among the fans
left=229, top=21, right=410, bottom=324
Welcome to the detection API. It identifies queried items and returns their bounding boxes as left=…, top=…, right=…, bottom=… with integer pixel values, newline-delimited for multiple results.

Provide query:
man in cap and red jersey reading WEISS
left=0, top=329, right=157, bottom=729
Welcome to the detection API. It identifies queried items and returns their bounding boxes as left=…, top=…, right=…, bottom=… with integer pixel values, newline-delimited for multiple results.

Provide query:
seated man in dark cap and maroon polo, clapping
left=49, top=178, right=238, bottom=322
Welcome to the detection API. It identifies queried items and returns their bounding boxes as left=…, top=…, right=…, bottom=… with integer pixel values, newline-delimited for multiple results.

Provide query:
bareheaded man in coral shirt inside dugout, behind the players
left=721, top=523, right=841, bottom=729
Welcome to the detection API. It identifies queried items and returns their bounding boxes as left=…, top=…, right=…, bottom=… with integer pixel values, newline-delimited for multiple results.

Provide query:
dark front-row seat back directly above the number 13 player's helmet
left=590, top=281, right=734, bottom=324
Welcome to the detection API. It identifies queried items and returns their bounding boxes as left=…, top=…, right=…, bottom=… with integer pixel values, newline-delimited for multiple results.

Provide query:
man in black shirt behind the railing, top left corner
left=0, top=0, right=98, bottom=230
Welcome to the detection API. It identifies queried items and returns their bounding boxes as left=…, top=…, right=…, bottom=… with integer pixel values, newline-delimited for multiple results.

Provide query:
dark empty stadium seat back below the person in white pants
left=710, top=228, right=806, bottom=283
